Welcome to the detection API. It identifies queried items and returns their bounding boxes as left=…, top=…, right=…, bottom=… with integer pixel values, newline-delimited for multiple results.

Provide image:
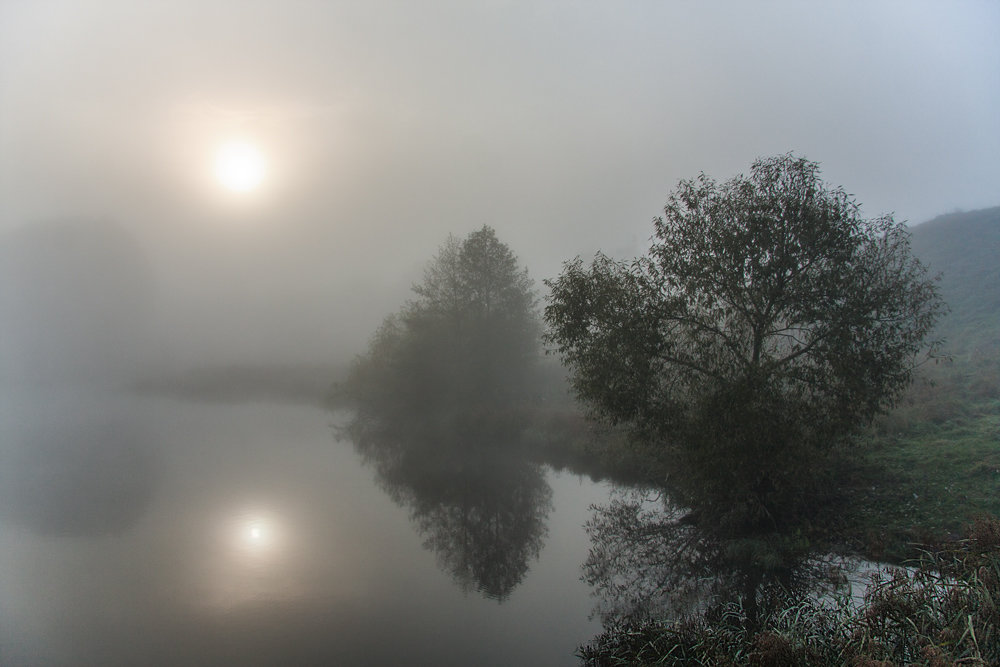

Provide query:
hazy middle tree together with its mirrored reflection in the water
left=335, top=227, right=552, bottom=600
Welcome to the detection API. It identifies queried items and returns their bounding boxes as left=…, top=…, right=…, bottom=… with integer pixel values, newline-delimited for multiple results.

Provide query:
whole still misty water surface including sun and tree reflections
left=0, top=396, right=609, bottom=665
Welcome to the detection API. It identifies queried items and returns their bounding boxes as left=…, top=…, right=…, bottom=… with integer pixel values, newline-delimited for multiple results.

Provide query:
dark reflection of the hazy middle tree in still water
left=347, top=424, right=552, bottom=601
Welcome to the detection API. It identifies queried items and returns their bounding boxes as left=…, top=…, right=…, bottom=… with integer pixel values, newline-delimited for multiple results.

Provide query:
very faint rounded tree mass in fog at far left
left=0, top=220, right=156, bottom=386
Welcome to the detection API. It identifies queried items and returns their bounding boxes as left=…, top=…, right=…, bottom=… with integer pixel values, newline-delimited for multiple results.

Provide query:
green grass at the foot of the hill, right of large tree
left=849, top=364, right=1000, bottom=562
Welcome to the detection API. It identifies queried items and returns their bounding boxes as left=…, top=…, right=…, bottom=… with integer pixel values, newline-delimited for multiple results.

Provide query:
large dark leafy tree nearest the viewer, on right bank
left=545, top=155, right=944, bottom=620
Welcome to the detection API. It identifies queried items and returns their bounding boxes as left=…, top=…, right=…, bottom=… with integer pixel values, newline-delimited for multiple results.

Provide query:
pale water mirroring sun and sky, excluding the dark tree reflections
left=0, top=401, right=607, bottom=665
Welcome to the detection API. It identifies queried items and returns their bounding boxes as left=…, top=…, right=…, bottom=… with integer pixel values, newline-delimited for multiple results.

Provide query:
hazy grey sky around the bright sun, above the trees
left=0, top=0, right=1000, bottom=363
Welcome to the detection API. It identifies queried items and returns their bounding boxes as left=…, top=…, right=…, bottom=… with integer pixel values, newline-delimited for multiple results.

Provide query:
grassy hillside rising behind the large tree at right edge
left=857, top=207, right=1000, bottom=558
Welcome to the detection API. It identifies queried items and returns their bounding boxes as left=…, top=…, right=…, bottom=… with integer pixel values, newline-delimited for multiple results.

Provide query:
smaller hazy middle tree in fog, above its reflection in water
left=340, top=227, right=540, bottom=424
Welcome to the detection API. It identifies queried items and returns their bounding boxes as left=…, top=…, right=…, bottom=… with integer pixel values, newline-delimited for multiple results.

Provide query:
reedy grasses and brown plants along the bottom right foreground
left=579, top=519, right=1000, bottom=667
